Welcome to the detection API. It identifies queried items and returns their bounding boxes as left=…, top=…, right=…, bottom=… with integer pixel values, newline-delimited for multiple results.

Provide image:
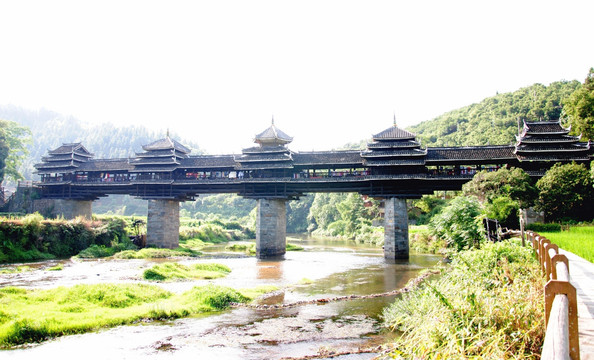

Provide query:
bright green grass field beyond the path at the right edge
left=539, top=226, right=594, bottom=263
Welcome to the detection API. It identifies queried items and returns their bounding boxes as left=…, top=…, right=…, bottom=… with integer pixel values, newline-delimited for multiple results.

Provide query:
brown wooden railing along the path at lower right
left=526, top=231, right=580, bottom=360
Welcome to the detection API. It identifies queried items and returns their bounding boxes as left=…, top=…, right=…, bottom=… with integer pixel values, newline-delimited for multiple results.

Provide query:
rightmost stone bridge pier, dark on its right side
left=384, top=197, right=408, bottom=260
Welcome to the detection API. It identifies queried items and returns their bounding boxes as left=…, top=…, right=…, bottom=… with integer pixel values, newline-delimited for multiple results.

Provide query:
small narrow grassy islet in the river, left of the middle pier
left=142, top=262, right=231, bottom=281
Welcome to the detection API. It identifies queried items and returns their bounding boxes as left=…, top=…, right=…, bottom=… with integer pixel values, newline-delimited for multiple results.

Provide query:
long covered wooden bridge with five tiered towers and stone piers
left=35, top=121, right=593, bottom=259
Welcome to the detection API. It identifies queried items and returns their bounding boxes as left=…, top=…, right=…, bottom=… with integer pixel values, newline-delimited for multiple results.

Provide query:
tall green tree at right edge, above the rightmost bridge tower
left=563, top=68, right=594, bottom=140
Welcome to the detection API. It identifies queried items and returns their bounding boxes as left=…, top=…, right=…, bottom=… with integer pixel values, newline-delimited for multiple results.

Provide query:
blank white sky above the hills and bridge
left=0, top=0, right=594, bottom=154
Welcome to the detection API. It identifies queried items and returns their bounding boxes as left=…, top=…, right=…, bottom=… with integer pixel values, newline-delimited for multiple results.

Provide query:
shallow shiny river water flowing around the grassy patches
left=0, top=238, right=439, bottom=360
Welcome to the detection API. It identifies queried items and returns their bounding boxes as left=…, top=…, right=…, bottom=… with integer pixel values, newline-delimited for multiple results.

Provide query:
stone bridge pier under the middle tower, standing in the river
left=256, top=199, right=287, bottom=259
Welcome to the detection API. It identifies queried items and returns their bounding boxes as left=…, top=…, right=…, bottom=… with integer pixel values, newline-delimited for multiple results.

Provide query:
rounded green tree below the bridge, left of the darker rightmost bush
left=462, top=168, right=538, bottom=210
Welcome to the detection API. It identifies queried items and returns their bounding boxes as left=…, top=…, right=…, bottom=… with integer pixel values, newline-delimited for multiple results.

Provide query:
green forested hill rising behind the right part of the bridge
left=408, top=80, right=581, bottom=146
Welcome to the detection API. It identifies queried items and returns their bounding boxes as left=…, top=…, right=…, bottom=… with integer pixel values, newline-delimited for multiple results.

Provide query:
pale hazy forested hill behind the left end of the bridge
left=0, top=105, right=202, bottom=179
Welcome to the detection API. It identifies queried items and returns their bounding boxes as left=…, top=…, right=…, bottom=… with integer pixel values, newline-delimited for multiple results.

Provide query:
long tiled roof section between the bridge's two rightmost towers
left=427, top=145, right=516, bottom=165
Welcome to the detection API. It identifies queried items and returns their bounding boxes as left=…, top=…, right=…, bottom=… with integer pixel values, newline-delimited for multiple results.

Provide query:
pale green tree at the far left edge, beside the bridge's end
left=0, top=120, right=31, bottom=183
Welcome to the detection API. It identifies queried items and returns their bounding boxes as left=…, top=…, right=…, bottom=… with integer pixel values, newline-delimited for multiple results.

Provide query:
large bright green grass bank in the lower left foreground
left=0, top=284, right=270, bottom=348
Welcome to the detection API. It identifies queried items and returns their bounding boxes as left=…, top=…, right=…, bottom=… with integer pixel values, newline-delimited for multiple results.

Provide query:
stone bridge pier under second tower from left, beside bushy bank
left=146, top=200, right=179, bottom=249
